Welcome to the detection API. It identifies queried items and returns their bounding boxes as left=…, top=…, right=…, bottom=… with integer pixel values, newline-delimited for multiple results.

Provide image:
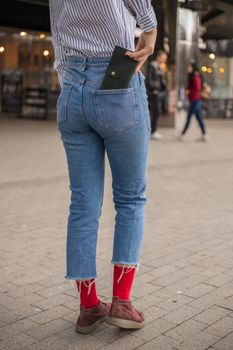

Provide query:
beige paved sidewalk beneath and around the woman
left=0, top=119, right=233, bottom=350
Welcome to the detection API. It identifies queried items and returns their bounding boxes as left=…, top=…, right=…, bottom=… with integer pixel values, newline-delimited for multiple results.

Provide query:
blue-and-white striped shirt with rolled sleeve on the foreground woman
left=49, top=0, right=157, bottom=84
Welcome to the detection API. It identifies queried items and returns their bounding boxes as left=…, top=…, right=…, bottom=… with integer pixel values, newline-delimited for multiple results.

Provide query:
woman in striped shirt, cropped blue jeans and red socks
left=50, top=0, right=156, bottom=333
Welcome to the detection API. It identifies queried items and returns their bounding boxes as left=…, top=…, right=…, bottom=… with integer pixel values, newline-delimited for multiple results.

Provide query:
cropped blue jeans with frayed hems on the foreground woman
left=57, top=56, right=150, bottom=280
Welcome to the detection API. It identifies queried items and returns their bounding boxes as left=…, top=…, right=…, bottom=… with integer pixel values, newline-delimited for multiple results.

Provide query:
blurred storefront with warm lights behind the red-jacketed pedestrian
left=176, top=0, right=233, bottom=118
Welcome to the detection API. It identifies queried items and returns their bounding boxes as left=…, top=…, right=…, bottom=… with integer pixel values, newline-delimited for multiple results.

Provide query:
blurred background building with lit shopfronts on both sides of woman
left=0, top=0, right=233, bottom=121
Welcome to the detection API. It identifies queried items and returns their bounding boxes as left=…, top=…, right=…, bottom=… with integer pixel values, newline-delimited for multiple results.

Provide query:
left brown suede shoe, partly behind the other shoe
left=76, top=301, right=110, bottom=334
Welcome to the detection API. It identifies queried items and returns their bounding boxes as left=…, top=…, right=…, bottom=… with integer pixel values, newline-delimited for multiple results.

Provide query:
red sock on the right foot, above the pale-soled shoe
left=113, top=265, right=136, bottom=300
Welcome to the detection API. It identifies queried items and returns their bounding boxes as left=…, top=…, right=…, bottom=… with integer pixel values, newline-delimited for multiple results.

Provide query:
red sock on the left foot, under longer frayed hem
left=76, top=278, right=100, bottom=309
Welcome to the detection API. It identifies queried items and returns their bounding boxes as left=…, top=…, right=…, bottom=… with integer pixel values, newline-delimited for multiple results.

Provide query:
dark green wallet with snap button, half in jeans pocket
left=100, top=46, right=138, bottom=90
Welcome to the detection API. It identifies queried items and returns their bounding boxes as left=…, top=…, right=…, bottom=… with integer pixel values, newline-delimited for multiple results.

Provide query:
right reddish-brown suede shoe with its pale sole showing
left=106, top=297, right=144, bottom=329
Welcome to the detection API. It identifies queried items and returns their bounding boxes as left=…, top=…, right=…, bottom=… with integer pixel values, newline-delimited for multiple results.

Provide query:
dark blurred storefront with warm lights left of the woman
left=0, top=27, right=59, bottom=118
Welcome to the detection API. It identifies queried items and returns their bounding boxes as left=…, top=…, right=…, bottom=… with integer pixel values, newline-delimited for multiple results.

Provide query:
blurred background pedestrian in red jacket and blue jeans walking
left=181, top=63, right=208, bottom=141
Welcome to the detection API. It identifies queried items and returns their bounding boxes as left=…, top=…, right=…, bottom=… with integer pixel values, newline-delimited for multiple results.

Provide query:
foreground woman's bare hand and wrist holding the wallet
left=125, top=28, right=157, bottom=74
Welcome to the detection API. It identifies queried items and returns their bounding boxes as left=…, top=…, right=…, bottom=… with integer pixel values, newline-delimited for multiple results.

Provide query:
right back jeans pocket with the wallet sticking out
left=92, top=86, right=139, bottom=131
